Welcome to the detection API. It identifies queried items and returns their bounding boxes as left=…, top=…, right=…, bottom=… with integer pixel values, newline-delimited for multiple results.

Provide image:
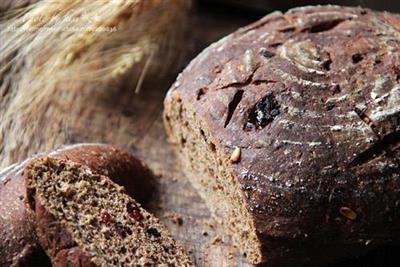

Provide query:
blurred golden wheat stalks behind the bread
left=0, top=0, right=188, bottom=168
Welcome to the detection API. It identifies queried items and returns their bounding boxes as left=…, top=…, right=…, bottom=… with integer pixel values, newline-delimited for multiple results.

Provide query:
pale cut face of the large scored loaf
left=164, top=94, right=266, bottom=264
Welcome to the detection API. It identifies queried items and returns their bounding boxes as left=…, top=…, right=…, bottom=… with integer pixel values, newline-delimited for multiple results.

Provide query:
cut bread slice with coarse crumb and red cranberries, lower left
left=25, top=157, right=193, bottom=267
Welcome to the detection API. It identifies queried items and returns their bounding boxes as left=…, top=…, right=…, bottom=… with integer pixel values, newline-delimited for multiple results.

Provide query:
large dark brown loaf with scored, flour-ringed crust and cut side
left=164, top=6, right=400, bottom=266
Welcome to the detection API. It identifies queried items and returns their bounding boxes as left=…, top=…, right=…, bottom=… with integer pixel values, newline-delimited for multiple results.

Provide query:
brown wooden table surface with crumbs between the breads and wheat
left=1, top=2, right=400, bottom=267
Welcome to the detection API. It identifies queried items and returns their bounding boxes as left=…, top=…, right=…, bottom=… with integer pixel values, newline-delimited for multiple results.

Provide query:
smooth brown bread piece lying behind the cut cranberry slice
left=0, top=144, right=150, bottom=266
